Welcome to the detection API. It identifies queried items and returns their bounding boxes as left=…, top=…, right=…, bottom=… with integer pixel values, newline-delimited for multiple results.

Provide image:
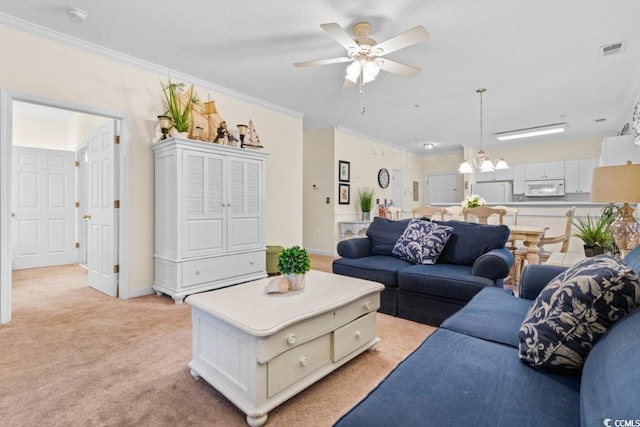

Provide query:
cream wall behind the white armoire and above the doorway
left=0, top=26, right=302, bottom=294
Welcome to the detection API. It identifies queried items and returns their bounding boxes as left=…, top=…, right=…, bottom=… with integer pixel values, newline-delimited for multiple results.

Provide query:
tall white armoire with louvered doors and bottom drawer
left=153, top=138, right=267, bottom=304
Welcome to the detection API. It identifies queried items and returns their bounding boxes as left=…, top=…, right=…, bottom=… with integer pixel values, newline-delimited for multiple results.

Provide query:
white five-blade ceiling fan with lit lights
left=294, top=22, right=429, bottom=88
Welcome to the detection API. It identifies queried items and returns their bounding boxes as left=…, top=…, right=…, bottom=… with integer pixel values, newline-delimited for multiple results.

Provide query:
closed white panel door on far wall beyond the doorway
left=12, top=146, right=77, bottom=270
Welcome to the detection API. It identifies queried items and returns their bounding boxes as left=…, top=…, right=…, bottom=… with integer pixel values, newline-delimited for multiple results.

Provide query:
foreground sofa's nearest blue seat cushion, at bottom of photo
left=335, top=329, right=580, bottom=427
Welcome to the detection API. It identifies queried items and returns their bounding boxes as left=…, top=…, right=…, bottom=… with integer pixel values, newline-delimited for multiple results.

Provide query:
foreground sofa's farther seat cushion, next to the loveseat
left=440, top=287, right=531, bottom=348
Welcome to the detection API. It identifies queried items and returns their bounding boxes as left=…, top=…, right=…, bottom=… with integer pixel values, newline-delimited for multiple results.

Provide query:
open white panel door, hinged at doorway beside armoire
left=84, top=122, right=118, bottom=296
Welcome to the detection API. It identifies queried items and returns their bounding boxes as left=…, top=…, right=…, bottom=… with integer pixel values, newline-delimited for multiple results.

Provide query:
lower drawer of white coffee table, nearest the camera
left=267, top=334, right=331, bottom=397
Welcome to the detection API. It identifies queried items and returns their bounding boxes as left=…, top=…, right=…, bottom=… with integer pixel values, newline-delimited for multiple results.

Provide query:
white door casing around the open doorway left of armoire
left=0, top=89, right=130, bottom=323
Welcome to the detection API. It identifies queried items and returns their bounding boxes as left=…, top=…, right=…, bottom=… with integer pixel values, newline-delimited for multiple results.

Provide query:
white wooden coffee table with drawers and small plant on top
left=186, top=270, right=384, bottom=426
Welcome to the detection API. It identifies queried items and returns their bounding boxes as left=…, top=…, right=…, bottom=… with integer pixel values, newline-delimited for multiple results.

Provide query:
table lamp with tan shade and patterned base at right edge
left=591, top=161, right=640, bottom=258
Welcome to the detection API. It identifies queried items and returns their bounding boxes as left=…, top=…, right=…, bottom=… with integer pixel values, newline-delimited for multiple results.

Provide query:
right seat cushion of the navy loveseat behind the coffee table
left=398, top=264, right=494, bottom=301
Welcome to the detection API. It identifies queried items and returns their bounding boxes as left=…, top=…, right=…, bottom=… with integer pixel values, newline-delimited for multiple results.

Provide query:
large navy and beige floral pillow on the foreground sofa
left=518, top=255, right=640, bottom=373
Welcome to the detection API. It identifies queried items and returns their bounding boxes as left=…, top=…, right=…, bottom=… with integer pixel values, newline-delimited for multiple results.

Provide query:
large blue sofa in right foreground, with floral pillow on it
left=335, top=246, right=640, bottom=427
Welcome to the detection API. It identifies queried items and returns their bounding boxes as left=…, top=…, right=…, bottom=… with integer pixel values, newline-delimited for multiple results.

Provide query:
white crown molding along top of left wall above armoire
left=0, top=13, right=304, bottom=118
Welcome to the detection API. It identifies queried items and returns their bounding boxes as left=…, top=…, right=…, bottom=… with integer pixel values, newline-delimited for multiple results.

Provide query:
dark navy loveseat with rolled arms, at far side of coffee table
left=333, top=218, right=513, bottom=326
